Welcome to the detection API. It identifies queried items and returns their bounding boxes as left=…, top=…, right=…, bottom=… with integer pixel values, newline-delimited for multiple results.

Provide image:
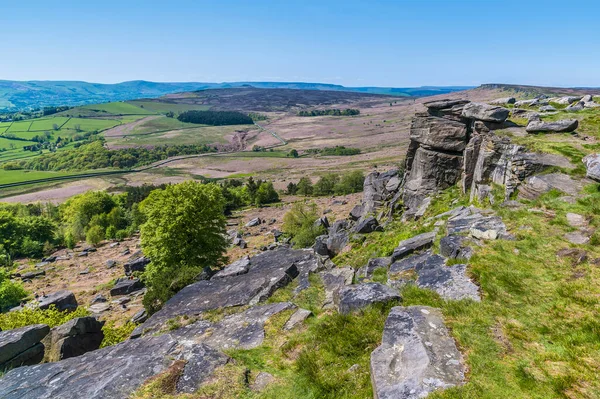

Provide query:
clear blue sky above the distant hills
left=0, top=0, right=600, bottom=87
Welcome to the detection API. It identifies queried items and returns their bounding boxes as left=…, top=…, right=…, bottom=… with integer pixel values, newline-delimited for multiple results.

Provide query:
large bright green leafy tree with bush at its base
left=140, top=181, right=228, bottom=313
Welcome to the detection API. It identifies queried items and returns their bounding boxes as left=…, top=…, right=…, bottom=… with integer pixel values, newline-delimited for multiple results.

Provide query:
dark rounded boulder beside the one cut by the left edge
left=44, top=316, right=104, bottom=362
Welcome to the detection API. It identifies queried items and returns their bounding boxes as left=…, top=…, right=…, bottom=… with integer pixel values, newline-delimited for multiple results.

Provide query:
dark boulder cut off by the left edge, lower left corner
left=0, top=324, right=50, bottom=372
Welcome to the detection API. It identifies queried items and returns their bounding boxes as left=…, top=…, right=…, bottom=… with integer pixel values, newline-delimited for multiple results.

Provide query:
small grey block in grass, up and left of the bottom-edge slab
left=338, top=283, right=402, bottom=314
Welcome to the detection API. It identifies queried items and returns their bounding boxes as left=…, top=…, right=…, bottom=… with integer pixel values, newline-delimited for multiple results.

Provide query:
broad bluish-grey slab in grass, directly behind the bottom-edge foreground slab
left=388, top=255, right=481, bottom=301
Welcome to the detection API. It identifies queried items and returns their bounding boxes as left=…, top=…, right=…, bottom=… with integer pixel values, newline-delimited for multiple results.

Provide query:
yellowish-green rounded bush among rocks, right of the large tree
left=281, top=202, right=325, bottom=248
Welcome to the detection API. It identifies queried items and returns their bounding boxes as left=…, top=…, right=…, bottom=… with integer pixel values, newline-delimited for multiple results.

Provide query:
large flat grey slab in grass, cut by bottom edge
left=371, top=306, right=465, bottom=399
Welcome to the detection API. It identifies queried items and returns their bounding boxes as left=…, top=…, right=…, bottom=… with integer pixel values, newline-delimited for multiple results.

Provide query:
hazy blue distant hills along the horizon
left=0, top=80, right=471, bottom=112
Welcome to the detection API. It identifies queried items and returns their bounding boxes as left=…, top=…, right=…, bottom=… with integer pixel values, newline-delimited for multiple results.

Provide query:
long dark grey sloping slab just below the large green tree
left=132, top=247, right=315, bottom=337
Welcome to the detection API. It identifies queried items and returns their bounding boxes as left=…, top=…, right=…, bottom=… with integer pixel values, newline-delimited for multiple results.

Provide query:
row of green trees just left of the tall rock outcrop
left=286, top=170, right=365, bottom=197
